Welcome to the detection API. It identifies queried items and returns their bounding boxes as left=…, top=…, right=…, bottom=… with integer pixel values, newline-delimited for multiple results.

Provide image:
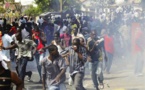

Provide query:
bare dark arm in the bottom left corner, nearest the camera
left=11, top=72, right=23, bottom=90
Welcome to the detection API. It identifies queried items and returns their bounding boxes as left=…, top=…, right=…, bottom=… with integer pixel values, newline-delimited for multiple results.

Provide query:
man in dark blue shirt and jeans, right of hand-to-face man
left=87, top=31, right=103, bottom=90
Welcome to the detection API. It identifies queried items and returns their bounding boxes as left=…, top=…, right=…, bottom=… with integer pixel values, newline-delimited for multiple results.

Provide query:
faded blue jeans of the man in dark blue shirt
left=89, top=61, right=99, bottom=88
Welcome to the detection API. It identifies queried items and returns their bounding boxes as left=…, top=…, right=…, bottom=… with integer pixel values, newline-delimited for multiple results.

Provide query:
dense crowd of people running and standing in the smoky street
left=0, top=7, right=145, bottom=90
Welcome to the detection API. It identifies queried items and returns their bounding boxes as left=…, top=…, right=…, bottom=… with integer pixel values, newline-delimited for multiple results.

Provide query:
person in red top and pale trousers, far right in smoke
left=134, top=28, right=145, bottom=76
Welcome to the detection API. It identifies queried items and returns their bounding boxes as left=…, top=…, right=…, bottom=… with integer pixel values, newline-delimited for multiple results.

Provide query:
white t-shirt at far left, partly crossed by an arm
left=2, top=34, right=13, bottom=59
